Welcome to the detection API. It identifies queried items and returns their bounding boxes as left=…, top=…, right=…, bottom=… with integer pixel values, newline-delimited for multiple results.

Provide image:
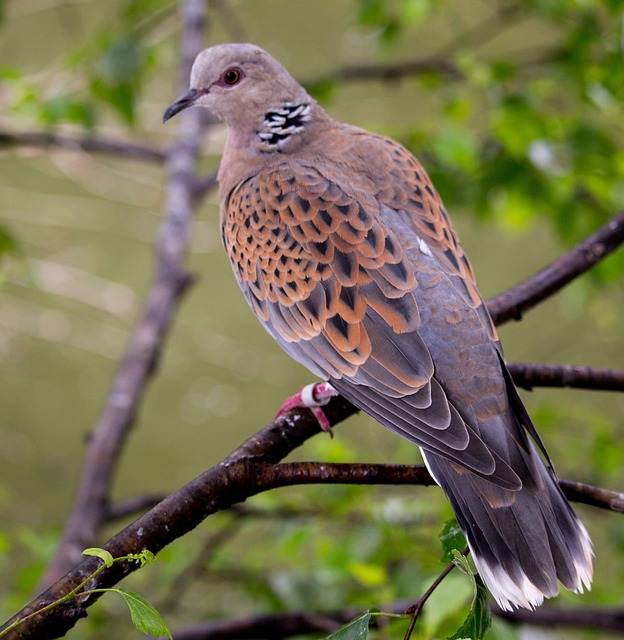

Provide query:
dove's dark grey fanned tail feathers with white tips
left=423, top=443, right=593, bottom=610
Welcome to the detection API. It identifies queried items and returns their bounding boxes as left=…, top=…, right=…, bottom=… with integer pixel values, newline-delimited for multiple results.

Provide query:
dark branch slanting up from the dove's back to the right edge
left=487, top=211, right=624, bottom=325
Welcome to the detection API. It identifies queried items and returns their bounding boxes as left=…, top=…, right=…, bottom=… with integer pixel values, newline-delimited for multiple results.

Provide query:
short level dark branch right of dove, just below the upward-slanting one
left=507, top=362, right=624, bottom=391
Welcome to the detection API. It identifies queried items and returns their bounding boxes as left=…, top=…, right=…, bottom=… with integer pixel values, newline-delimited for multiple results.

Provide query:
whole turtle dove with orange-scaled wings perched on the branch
left=163, top=43, right=593, bottom=610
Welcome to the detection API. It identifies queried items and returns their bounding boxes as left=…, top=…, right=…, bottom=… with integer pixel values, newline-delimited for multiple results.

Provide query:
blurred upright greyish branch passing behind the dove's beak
left=42, top=0, right=210, bottom=587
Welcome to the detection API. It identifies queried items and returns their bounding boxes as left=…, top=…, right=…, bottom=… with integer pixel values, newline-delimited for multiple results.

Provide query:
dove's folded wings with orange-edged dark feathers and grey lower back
left=222, top=140, right=526, bottom=489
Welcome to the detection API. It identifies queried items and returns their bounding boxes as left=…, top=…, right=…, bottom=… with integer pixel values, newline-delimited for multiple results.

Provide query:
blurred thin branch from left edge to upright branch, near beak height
left=0, top=131, right=167, bottom=162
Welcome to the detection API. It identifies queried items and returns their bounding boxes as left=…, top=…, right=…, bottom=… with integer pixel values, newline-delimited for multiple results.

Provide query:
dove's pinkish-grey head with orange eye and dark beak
left=163, top=44, right=313, bottom=129
